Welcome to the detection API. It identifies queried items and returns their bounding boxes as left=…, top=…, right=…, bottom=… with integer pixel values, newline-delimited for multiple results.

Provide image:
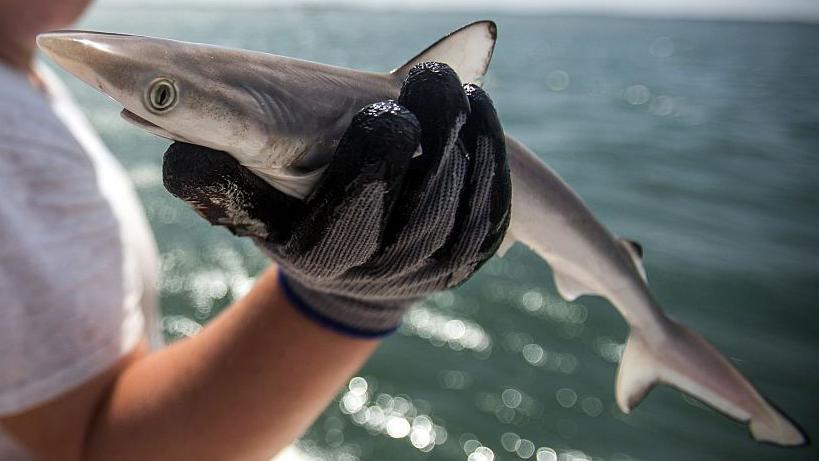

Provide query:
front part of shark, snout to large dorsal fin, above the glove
left=37, top=21, right=496, bottom=197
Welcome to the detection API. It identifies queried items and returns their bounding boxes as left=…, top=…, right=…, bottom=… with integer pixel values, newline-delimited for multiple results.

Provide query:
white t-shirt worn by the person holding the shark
left=0, top=65, right=161, bottom=461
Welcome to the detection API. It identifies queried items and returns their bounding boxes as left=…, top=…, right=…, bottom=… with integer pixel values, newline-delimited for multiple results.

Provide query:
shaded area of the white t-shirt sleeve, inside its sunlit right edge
left=0, top=66, right=143, bottom=415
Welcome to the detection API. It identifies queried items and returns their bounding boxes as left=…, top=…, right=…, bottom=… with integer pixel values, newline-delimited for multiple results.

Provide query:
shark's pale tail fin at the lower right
left=616, top=320, right=807, bottom=445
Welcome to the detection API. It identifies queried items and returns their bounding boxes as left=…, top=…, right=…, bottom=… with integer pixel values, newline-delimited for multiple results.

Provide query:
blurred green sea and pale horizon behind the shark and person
left=52, top=0, right=819, bottom=461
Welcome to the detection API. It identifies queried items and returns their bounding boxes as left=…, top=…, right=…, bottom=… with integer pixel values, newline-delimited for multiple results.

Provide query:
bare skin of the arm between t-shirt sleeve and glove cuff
left=2, top=262, right=378, bottom=461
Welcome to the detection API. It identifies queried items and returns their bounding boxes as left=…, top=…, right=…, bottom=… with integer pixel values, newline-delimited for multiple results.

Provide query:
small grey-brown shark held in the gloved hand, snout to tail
left=37, top=21, right=807, bottom=445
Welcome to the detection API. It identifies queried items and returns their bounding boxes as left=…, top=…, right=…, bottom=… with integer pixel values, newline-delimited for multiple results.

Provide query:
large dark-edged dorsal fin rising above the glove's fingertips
left=390, top=21, right=498, bottom=84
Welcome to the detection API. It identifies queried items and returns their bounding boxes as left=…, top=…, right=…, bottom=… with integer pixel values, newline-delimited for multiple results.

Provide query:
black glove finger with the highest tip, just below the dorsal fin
left=387, top=62, right=469, bottom=246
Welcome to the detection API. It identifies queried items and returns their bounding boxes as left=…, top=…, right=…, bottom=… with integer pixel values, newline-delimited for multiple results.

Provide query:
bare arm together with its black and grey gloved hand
left=0, top=63, right=511, bottom=461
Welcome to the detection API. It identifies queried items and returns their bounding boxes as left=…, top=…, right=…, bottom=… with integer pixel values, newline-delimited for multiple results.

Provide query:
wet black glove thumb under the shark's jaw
left=162, top=142, right=304, bottom=241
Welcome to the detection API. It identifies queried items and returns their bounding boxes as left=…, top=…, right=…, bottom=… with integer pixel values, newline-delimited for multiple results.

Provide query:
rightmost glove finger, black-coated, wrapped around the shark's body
left=436, top=84, right=512, bottom=286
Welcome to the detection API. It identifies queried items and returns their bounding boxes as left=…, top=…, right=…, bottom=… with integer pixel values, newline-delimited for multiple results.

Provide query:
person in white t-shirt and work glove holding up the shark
left=0, top=0, right=511, bottom=461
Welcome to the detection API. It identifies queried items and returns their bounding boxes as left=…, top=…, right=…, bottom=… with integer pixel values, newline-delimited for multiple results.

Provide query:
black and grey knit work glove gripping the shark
left=163, top=63, right=511, bottom=337
